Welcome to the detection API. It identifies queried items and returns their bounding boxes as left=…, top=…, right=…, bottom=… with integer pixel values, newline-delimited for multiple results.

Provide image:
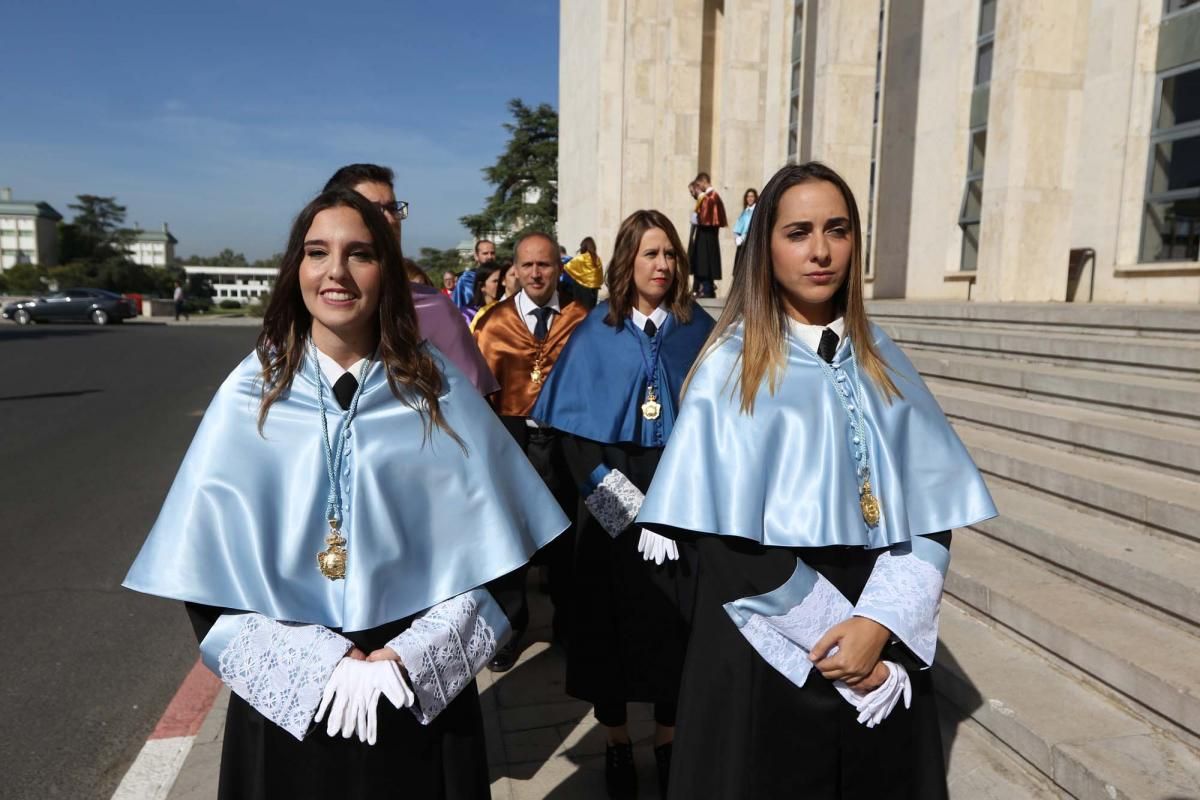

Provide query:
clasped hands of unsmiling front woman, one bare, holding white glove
left=809, top=616, right=912, bottom=728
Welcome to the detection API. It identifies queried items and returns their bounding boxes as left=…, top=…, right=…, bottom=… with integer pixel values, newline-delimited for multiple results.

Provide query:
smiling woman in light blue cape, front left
left=125, top=190, right=568, bottom=799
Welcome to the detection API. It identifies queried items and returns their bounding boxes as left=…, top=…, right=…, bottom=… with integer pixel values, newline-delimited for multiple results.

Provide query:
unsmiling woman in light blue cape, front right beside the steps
left=637, top=163, right=996, bottom=800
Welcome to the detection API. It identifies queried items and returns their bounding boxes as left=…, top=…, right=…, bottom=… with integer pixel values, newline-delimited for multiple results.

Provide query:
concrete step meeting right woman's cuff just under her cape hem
left=946, top=530, right=1200, bottom=741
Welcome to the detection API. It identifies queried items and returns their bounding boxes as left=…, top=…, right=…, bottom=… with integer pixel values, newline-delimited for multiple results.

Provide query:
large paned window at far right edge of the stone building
left=1139, top=63, right=1200, bottom=261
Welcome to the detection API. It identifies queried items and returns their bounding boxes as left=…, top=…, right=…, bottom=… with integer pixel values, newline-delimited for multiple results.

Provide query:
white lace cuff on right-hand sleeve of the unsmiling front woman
left=854, top=536, right=949, bottom=667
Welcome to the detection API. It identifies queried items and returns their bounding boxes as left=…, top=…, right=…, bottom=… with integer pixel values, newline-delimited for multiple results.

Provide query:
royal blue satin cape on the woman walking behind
left=530, top=302, right=713, bottom=447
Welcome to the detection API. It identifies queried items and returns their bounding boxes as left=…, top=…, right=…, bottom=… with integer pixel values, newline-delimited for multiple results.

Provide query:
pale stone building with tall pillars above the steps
left=558, top=0, right=1200, bottom=302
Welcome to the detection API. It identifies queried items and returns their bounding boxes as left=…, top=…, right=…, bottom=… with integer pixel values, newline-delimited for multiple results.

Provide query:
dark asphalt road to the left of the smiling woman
left=0, top=323, right=257, bottom=800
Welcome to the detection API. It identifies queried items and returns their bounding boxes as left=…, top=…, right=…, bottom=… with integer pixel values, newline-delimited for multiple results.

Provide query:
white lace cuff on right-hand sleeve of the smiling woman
left=388, top=589, right=510, bottom=724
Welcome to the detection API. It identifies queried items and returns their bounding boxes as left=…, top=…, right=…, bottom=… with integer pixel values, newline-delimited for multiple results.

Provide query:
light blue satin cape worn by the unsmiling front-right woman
left=637, top=325, right=996, bottom=549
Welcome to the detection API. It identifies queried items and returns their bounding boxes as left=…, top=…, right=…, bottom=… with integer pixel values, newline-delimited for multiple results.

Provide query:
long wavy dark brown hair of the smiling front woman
left=256, top=188, right=462, bottom=445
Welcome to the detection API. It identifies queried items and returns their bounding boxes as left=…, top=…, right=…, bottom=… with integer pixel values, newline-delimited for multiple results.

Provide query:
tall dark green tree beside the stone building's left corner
left=460, top=98, right=558, bottom=257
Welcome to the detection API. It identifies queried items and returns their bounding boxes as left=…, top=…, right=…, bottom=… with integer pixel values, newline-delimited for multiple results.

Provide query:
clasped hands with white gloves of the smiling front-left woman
left=316, top=648, right=416, bottom=745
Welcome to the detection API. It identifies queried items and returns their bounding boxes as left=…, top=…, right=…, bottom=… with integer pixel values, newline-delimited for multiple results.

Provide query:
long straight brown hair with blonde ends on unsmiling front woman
left=684, top=161, right=901, bottom=414
